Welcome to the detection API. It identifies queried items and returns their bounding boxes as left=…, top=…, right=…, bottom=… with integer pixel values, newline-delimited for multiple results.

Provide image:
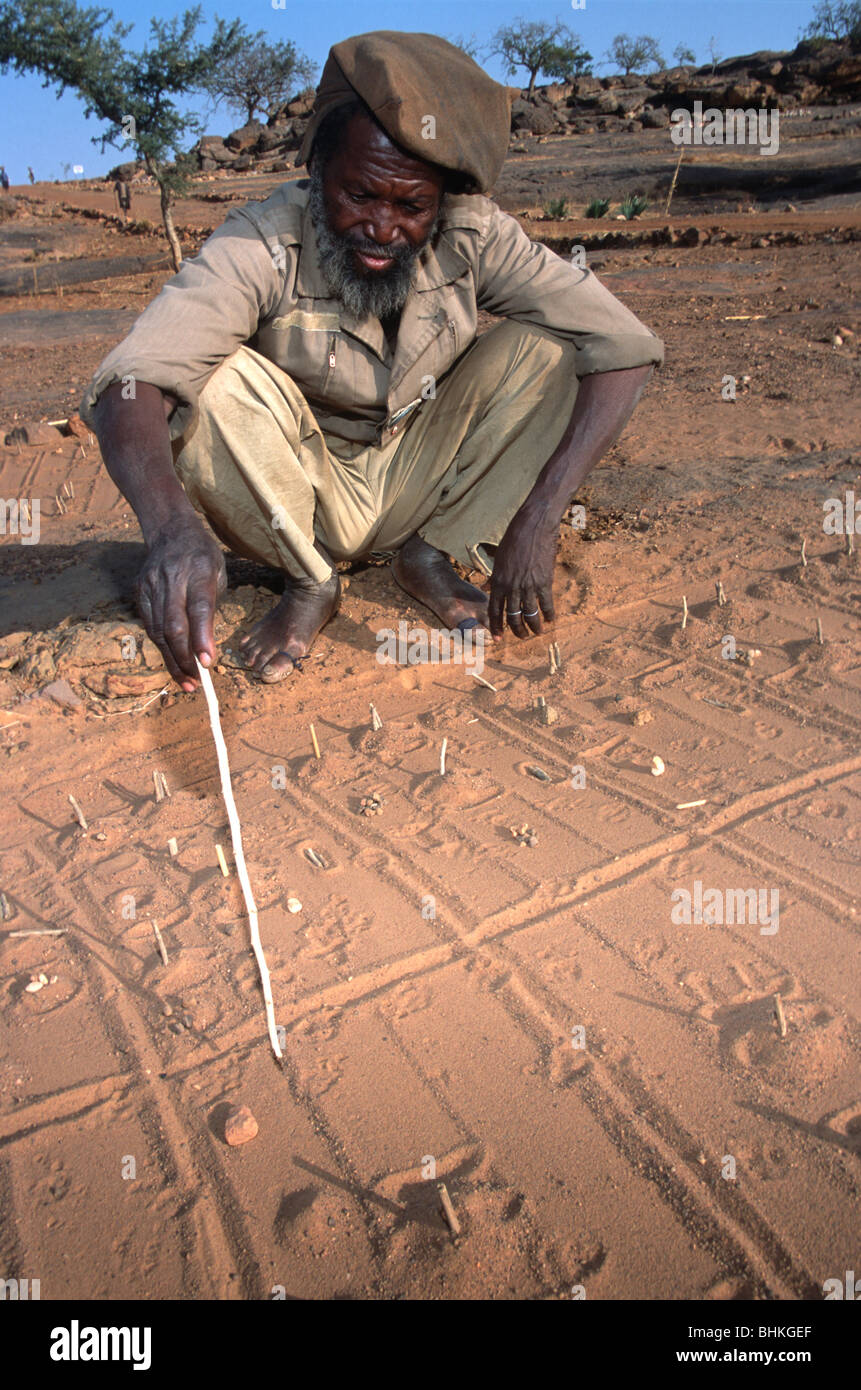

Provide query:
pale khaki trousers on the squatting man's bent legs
left=174, top=320, right=577, bottom=581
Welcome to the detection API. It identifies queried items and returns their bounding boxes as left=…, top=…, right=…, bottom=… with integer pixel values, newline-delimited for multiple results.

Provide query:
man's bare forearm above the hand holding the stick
left=95, top=381, right=198, bottom=545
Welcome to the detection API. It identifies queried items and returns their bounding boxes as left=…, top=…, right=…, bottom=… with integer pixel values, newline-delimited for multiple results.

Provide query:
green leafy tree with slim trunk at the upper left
left=0, top=0, right=243, bottom=270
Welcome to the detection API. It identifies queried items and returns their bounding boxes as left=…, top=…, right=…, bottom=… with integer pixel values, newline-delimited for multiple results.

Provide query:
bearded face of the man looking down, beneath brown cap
left=310, top=115, right=444, bottom=318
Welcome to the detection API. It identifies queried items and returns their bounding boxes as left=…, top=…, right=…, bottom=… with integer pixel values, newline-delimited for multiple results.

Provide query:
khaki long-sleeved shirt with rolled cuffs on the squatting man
left=81, top=179, right=663, bottom=452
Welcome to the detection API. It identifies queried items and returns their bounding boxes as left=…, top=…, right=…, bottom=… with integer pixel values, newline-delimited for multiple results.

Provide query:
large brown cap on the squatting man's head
left=296, top=29, right=510, bottom=193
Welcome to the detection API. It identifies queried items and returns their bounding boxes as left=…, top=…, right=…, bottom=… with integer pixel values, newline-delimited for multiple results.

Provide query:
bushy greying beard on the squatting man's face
left=307, top=167, right=440, bottom=318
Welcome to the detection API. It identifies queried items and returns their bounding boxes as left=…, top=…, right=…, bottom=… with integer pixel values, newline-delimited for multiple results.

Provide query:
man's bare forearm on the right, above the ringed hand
left=519, top=366, right=654, bottom=530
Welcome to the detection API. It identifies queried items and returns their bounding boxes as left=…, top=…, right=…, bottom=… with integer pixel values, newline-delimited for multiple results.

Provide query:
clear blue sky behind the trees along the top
left=0, top=0, right=814, bottom=183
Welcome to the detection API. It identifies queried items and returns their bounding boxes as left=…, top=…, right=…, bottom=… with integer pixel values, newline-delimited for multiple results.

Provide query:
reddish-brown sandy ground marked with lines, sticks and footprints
left=0, top=132, right=861, bottom=1300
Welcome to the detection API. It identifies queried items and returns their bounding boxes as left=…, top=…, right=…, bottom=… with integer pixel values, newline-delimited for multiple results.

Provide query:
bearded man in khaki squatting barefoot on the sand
left=82, top=31, right=662, bottom=691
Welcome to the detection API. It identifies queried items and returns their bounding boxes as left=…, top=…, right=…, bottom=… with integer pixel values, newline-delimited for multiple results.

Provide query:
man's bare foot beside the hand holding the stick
left=239, top=574, right=341, bottom=684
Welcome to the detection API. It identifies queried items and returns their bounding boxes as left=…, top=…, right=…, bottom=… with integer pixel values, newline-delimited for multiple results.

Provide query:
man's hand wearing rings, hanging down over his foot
left=490, top=512, right=559, bottom=638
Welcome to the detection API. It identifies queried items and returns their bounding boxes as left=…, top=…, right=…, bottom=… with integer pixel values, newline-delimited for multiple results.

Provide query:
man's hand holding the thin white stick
left=136, top=517, right=227, bottom=691
